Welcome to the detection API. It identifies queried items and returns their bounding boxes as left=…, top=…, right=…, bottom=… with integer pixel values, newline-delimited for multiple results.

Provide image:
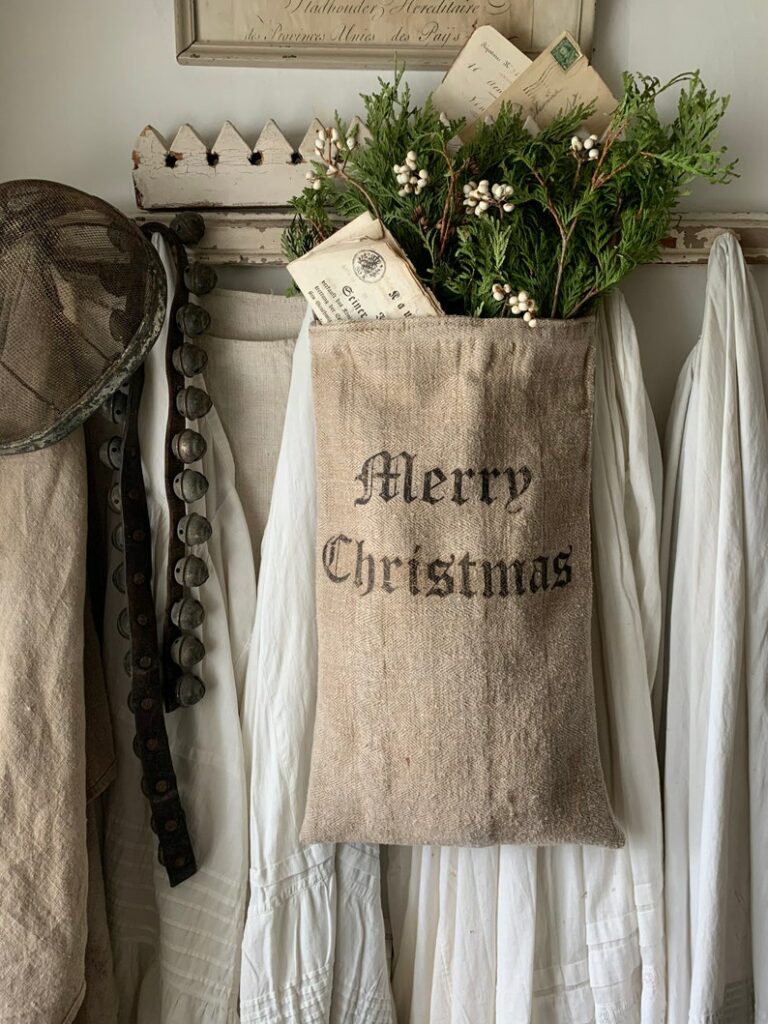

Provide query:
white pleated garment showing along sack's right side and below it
left=386, top=294, right=665, bottom=1024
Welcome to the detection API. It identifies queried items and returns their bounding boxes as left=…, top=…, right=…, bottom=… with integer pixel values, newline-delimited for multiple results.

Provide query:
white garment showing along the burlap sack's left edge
left=241, top=312, right=394, bottom=1024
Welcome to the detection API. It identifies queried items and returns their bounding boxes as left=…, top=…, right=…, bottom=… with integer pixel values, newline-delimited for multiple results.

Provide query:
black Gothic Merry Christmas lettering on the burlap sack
left=321, top=451, right=573, bottom=598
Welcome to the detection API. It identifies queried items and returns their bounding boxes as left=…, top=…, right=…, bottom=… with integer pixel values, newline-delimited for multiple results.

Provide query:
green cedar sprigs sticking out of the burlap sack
left=284, top=68, right=736, bottom=318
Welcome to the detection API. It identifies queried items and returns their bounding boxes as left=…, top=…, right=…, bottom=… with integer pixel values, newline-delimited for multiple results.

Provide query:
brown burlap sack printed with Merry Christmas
left=302, top=317, right=624, bottom=847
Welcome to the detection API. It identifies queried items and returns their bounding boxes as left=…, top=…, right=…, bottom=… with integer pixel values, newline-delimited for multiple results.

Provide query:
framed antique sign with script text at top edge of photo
left=175, top=0, right=595, bottom=69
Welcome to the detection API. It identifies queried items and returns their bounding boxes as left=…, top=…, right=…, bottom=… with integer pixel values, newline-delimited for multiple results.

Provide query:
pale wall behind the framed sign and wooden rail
left=0, top=0, right=768, bottom=421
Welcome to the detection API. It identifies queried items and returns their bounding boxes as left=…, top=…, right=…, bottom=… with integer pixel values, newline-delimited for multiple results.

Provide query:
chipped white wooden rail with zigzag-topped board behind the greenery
left=133, top=118, right=768, bottom=266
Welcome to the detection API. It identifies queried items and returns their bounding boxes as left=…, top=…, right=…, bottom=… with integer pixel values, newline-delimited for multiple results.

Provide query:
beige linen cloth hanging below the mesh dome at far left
left=0, top=431, right=117, bottom=1024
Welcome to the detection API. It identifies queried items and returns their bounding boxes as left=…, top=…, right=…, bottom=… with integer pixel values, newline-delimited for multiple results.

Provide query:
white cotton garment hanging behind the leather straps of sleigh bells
left=104, top=243, right=256, bottom=1024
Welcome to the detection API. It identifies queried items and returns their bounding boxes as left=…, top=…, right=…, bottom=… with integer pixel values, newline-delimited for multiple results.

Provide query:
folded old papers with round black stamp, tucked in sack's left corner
left=288, top=213, right=442, bottom=324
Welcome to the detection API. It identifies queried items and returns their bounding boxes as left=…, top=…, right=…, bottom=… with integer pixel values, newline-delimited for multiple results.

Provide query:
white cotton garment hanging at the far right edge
left=658, top=234, right=768, bottom=1024
